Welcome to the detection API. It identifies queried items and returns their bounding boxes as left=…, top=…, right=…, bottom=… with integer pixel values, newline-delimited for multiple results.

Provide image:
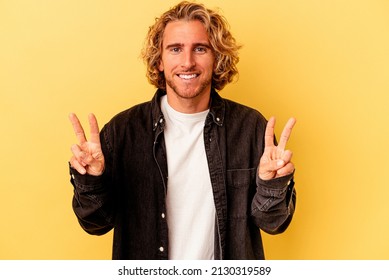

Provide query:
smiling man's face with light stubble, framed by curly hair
left=159, top=20, right=215, bottom=109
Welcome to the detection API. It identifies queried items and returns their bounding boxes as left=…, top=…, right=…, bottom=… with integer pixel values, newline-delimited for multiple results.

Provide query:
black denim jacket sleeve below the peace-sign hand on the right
left=251, top=173, right=296, bottom=234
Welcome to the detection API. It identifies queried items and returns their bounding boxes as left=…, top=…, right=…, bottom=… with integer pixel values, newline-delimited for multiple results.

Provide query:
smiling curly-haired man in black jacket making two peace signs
left=70, top=2, right=296, bottom=259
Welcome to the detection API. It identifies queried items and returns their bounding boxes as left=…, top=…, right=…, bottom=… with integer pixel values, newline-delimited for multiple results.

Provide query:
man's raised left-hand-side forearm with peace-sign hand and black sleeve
left=69, top=114, right=113, bottom=235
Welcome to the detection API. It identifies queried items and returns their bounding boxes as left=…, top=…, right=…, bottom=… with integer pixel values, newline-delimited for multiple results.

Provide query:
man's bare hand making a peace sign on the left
left=69, top=113, right=105, bottom=176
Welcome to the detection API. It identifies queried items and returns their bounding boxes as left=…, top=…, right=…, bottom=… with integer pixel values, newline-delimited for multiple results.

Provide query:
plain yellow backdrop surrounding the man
left=0, top=0, right=389, bottom=259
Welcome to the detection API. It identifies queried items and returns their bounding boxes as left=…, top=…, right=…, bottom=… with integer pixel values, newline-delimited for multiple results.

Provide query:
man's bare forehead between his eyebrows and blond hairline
left=163, top=20, right=209, bottom=45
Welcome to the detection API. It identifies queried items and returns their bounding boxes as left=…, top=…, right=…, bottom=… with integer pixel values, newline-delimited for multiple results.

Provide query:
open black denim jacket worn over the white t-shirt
left=70, top=90, right=296, bottom=259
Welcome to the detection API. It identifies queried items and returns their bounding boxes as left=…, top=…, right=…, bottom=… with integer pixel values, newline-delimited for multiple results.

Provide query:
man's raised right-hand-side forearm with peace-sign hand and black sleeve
left=251, top=118, right=296, bottom=234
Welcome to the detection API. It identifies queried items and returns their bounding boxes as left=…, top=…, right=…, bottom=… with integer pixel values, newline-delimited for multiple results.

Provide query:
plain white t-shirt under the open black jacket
left=161, top=95, right=215, bottom=260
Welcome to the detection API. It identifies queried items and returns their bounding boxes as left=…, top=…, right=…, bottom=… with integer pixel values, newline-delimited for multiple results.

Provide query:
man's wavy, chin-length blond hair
left=141, top=1, right=240, bottom=90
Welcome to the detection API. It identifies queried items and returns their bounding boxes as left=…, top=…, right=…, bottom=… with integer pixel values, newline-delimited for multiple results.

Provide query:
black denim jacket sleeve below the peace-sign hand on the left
left=69, top=124, right=114, bottom=235
